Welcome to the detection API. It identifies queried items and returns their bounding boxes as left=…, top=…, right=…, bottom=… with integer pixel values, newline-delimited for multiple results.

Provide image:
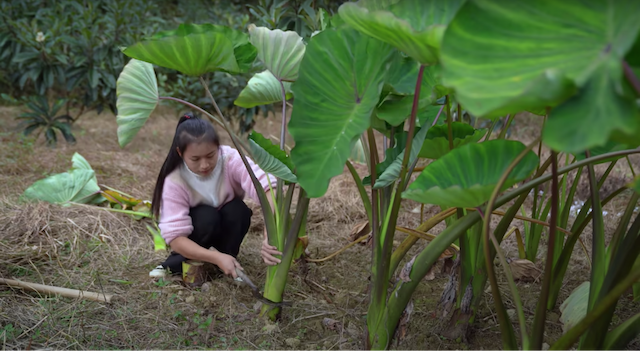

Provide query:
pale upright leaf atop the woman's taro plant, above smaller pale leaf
left=249, top=26, right=306, bottom=82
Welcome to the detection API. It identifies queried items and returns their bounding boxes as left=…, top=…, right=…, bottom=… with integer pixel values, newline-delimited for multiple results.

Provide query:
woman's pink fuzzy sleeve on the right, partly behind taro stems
left=228, top=149, right=278, bottom=203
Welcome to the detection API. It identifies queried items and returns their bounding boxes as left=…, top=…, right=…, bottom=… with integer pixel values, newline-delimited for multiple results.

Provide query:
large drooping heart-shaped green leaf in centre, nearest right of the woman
left=288, top=27, right=392, bottom=198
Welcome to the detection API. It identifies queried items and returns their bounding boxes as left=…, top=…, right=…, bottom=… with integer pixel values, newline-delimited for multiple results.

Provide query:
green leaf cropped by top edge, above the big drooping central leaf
left=338, top=0, right=464, bottom=64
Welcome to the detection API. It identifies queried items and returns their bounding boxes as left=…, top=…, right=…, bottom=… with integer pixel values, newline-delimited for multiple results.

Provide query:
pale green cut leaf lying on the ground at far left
left=24, top=169, right=100, bottom=204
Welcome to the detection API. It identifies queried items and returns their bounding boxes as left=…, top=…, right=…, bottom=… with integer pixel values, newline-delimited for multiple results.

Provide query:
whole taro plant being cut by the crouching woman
left=117, top=24, right=309, bottom=319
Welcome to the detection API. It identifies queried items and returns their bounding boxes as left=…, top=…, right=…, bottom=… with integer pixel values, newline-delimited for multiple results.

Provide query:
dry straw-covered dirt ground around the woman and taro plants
left=0, top=102, right=640, bottom=351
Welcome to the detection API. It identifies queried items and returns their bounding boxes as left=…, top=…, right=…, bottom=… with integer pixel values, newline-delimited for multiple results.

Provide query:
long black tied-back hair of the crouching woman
left=151, top=112, right=220, bottom=218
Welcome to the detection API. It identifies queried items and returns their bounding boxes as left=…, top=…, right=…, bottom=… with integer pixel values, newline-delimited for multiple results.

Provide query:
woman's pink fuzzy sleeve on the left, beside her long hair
left=158, top=178, right=193, bottom=245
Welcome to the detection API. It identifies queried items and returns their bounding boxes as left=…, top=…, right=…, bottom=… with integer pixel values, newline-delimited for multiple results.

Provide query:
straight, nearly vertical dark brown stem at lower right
left=531, top=151, right=559, bottom=350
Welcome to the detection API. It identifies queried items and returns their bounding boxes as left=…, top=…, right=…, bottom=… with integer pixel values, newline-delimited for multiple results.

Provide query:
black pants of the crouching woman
left=162, top=198, right=253, bottom=274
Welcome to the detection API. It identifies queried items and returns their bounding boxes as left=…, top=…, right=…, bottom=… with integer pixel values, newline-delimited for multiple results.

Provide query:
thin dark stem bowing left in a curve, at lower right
left=482, top=136, right=538, bottom=350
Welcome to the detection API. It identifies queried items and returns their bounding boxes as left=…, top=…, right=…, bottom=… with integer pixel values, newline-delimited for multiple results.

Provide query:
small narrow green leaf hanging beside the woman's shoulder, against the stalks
left=249, top=132, right=297, bottom=183
